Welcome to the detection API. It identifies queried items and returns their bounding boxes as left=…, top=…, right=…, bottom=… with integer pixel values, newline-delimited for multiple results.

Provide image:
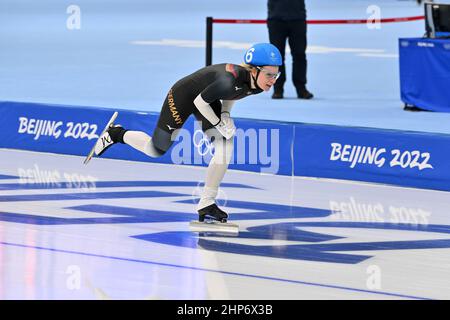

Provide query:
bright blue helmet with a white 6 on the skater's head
left=244, top=43, right=283, bottom=66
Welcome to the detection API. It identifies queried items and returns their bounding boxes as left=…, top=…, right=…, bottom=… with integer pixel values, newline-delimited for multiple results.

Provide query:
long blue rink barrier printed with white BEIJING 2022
left=0, top=102, right=450, bottom=190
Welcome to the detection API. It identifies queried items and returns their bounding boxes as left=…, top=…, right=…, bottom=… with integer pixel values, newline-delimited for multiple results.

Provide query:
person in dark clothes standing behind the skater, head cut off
left=267, top=0, right=313, bottom=99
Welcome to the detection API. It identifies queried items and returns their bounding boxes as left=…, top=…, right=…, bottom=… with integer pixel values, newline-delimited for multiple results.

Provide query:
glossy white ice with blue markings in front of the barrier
left=0, top=150, right=450, bottom=299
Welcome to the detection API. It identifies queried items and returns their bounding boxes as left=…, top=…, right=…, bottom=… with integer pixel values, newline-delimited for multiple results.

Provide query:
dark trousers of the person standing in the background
left=267, top=20, right=307, bottom=91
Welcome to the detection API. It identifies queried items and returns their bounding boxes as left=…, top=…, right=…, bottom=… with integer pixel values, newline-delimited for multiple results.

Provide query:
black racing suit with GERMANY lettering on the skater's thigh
left=152, top=63, right=263, bottom=153
